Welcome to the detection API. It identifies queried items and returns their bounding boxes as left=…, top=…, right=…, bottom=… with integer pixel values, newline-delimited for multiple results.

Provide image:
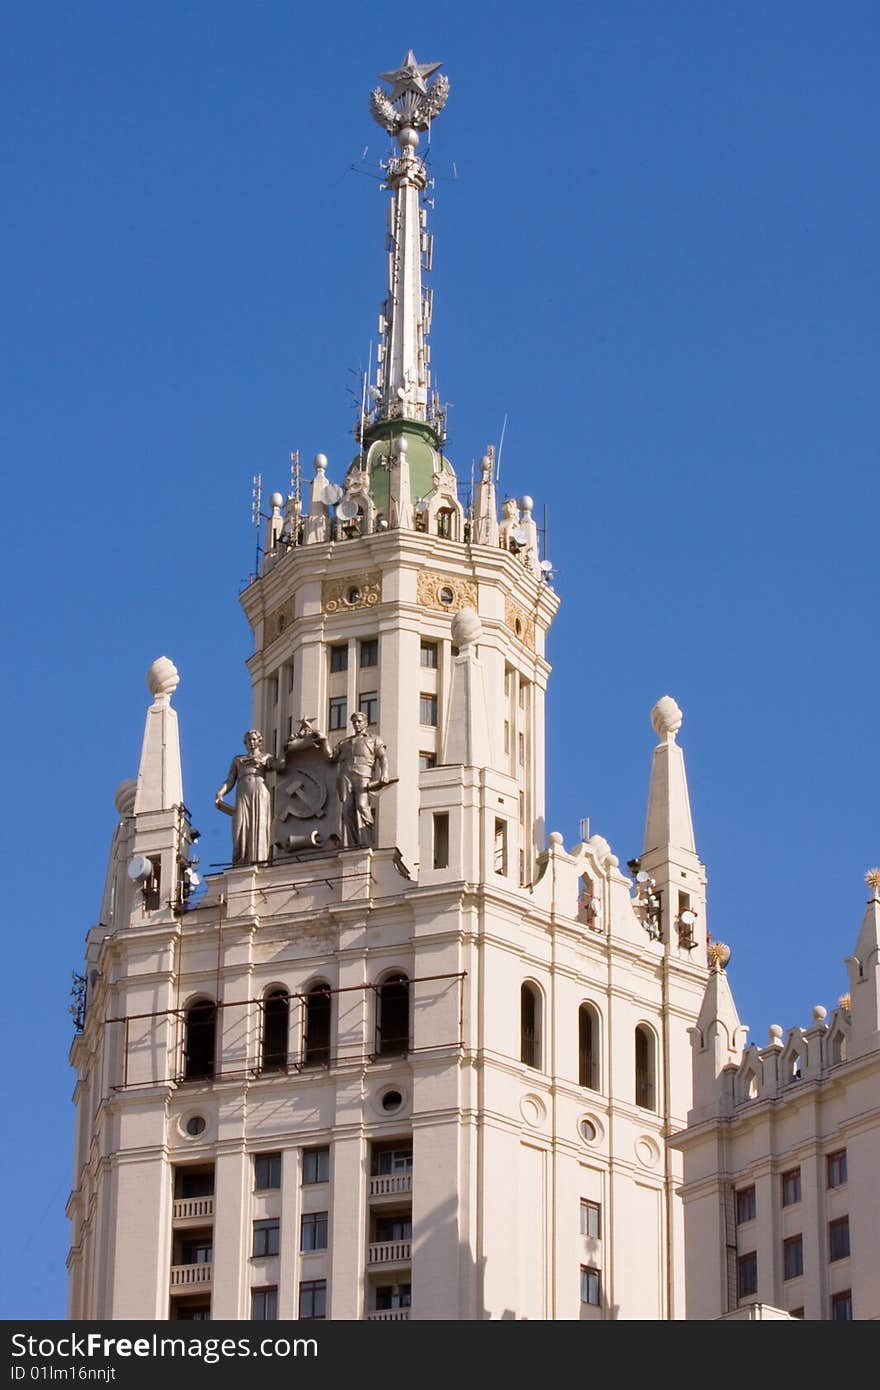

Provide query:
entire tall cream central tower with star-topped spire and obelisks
left=70, top=50, right=706, bottom=1321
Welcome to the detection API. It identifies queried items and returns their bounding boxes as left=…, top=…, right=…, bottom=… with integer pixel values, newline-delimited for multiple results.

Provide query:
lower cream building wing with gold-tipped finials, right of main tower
left=673, top=873, right=880, bottom=1321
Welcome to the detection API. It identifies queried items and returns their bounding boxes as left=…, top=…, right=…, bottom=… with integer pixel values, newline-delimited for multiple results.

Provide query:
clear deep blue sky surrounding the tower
left=0, top=0, right=880, bottom=1318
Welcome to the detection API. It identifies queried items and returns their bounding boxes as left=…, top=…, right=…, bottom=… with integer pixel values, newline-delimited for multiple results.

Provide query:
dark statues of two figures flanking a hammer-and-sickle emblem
left=214, top=710, right=389, bottom=865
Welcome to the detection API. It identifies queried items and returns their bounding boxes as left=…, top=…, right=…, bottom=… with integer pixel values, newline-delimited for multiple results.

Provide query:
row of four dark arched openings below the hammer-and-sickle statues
left=184, top=973, right=410, bottom=1081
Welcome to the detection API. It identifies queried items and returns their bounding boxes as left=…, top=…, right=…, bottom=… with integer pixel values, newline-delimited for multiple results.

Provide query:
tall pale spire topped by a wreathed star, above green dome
left=370, top=49, right=449, bottom=421
